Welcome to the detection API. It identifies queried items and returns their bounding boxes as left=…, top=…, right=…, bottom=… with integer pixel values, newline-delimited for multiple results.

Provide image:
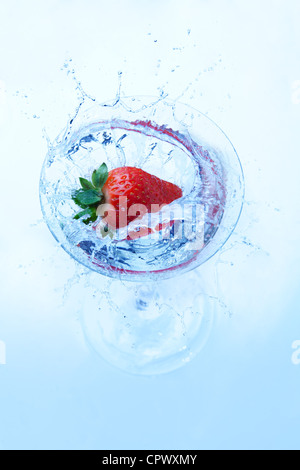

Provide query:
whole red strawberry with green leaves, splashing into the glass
left=73, top=163, right=182, bottom=229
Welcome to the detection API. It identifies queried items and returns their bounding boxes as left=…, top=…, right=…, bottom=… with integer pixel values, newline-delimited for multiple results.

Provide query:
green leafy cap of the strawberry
left=72, top=163, right=108, bottom=225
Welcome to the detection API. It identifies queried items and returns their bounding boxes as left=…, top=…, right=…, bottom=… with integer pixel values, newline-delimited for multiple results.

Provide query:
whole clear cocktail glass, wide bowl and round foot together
left=40, top=97, right=244, bottom=374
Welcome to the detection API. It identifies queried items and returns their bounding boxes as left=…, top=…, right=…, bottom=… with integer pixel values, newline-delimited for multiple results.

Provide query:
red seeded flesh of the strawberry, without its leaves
left=102, top=167, right=182, bottom=228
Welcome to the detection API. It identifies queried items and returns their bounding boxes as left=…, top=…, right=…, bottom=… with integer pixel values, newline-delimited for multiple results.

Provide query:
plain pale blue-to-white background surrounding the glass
left=0, top=0, right=300, bottom=449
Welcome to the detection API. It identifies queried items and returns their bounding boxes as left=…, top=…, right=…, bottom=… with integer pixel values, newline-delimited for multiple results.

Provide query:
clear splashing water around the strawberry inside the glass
left=41, top=92, right=244, bottom=277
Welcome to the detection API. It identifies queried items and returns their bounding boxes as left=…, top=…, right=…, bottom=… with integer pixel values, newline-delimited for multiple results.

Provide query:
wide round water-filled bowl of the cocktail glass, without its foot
left=40, top=93, right=244, bottom=281
